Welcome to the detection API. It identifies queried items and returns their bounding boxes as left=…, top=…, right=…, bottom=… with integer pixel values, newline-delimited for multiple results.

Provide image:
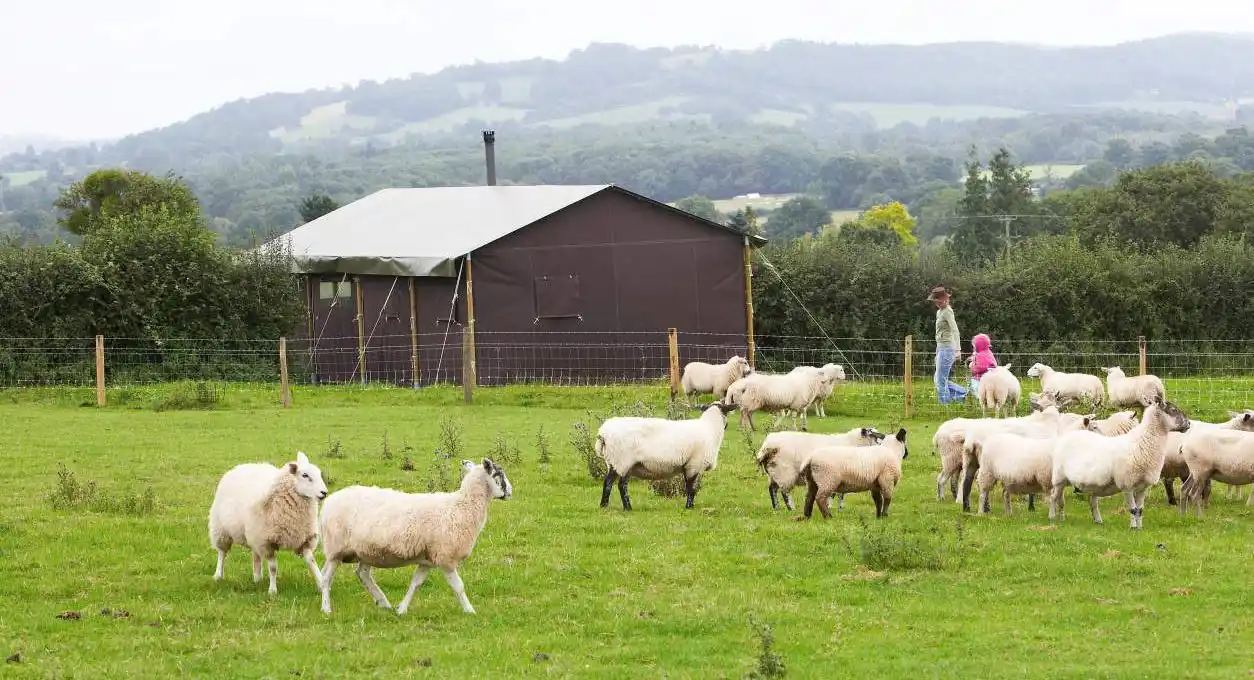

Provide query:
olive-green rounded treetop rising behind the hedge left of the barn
left=53, top=168, right=201, bottom=235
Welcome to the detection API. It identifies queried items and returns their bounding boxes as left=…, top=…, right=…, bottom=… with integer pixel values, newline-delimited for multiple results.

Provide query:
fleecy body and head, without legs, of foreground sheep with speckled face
left=321, top=465, right=493, bottom=570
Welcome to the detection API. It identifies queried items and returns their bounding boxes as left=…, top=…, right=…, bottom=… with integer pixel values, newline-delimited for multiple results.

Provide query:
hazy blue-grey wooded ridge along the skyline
left=14, top=34, right=1254, bottom=167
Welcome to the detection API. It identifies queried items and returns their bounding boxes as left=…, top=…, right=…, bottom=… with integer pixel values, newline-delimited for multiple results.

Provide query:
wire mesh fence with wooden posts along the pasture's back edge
left=0, top=326, right=1254, bottom=419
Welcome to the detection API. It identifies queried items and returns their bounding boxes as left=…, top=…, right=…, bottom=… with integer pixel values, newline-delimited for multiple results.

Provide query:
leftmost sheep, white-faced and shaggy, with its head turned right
left=209, top=452, right=326, bottom=595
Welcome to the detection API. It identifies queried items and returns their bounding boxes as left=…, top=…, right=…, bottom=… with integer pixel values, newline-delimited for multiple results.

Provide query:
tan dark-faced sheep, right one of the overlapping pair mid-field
left=796, top=428, right=910, bottom=521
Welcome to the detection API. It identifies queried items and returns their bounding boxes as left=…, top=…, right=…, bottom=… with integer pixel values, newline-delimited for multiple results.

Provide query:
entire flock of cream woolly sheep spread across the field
left=195, top=356, right=1254, bottom=615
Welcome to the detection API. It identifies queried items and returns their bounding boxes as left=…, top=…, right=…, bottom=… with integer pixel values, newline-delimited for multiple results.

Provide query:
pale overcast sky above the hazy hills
left=0, top=0, right=1254, bottom=138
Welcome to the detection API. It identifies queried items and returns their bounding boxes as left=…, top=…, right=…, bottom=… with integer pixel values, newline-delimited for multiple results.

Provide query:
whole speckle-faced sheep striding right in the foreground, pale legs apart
left=321, top=458, right=514, bottom=615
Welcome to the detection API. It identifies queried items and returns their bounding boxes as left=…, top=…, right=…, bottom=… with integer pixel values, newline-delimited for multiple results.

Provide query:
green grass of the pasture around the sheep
left=0, top=385, right=1254, bottom=677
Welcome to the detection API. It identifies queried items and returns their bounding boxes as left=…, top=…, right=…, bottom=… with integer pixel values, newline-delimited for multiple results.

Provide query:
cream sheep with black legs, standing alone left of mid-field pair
left=596, top=401, right=736, bottom=511
